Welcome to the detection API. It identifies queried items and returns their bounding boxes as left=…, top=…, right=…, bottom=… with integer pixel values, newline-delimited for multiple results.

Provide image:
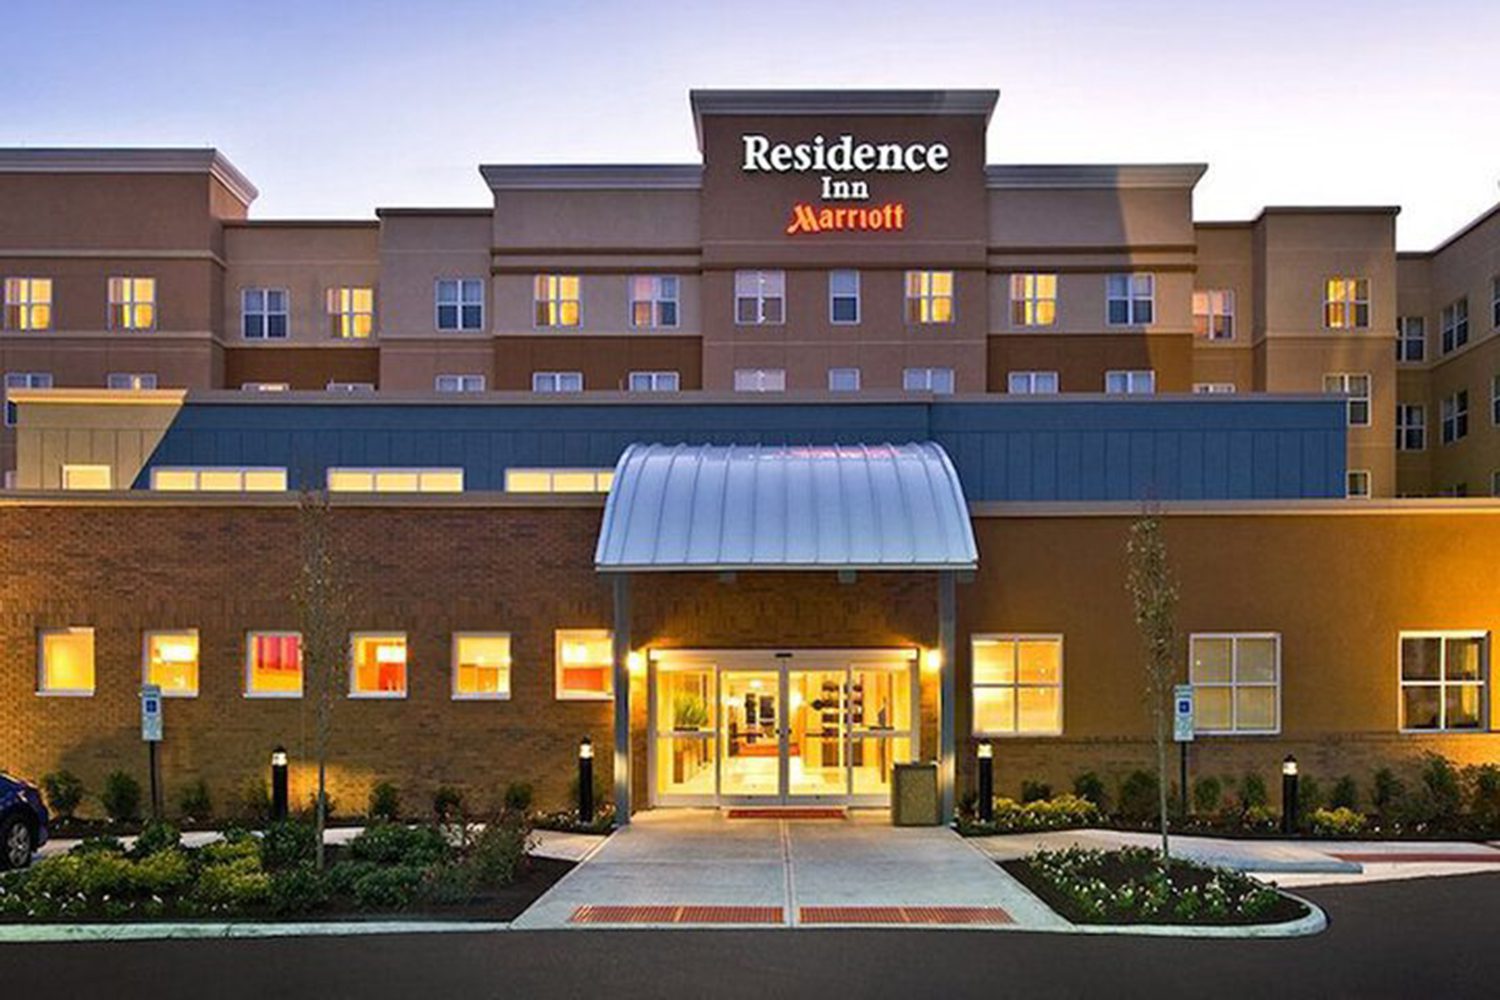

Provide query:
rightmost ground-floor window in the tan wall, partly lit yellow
left=1401, top=631, right=1490, bottom=730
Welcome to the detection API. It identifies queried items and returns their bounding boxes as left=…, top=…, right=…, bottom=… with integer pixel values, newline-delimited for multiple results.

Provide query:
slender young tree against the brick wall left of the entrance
left=293, top=490, right=353, bottom=870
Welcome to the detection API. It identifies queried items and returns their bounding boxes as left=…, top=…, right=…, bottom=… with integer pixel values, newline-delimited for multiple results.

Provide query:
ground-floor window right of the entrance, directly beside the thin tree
left=1188, top=633, right=1281, bottom=733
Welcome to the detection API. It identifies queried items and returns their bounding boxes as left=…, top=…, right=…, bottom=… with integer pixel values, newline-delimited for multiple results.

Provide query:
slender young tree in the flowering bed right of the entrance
left=1125, top=504, right=1178, bottom=864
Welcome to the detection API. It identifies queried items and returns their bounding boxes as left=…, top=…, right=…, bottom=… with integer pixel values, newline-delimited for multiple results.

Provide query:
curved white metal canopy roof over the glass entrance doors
left=594, top=442, right=978, bottom=571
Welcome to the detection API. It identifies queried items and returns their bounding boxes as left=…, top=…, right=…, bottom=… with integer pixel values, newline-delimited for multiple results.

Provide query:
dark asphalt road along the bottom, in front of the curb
left=0, top=873, right=1500, bottom=1000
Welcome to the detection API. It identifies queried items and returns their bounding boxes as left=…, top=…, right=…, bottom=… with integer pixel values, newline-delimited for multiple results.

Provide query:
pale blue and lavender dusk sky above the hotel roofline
left=0, top=0, right=1500, bottom=249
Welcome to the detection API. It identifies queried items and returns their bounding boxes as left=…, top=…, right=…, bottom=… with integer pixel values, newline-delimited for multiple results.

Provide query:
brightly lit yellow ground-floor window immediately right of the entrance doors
left=971, top=636, right=1062, bottom=736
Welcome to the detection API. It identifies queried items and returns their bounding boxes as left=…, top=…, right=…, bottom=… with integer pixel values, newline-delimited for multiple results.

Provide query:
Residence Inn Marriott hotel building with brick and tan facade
left=0, top=91, right=1500, bottom=813
